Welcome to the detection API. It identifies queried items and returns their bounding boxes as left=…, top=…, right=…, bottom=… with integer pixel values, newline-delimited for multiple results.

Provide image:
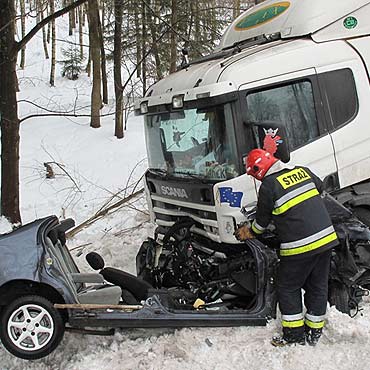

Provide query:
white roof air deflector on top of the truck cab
left=217, top=0, right=370, bottom=50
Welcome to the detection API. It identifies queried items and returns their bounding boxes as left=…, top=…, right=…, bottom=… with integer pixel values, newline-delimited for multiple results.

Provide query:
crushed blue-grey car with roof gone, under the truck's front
left=0, top=196, right=370, bottom=359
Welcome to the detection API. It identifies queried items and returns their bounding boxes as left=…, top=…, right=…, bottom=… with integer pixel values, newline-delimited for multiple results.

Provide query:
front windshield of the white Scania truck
left=145, top=104, right=239, bottom=180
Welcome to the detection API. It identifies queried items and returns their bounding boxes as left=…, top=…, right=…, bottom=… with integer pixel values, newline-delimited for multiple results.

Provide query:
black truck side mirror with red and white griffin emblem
left=253, top=121, right=290, bottom=163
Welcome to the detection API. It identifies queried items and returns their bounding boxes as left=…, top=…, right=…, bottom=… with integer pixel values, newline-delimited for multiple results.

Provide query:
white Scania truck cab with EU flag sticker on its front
left=136, top=0, right=370, bottom=244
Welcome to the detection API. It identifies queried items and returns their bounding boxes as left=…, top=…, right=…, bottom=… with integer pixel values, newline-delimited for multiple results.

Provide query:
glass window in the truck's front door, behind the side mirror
left=246, top=80, right=320, bottom=150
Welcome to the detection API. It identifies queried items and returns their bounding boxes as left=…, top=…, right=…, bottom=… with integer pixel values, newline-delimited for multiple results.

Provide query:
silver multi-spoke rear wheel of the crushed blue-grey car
left=0, top=295, right=65, bottom=360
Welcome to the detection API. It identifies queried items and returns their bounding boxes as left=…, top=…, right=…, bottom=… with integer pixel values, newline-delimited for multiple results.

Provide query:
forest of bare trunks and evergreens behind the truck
left=0, top=0, right=262, bottom=224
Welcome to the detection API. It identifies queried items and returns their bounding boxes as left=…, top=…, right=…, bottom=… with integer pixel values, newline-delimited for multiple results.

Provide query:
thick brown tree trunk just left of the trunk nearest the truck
left=87, top=0, right=102, bottom=128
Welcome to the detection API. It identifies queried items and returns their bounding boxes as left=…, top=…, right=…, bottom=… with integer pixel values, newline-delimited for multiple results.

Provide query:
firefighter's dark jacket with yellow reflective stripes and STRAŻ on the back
left=252, top=166, right=338, bottom=258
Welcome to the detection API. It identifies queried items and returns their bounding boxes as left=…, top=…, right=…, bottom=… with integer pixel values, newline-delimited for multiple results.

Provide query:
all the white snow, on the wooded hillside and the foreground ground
left=0, top=13, right=370, bottom=370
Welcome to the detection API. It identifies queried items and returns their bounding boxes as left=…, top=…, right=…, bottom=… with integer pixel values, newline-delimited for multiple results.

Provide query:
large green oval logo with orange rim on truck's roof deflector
left=235, top=1, right=290, bottom=31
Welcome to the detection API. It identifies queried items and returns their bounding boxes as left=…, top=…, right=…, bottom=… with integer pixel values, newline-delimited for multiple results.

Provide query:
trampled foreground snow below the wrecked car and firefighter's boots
left=0, top=307, right=370, bottom=370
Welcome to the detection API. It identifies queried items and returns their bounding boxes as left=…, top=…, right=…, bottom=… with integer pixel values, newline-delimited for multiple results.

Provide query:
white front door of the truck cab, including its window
left=240, top=69, right=337, bottom=184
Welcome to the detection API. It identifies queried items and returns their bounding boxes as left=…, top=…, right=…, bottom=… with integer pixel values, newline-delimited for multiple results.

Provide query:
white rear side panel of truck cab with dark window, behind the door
left=317, top=57, right=370, bottom=192
